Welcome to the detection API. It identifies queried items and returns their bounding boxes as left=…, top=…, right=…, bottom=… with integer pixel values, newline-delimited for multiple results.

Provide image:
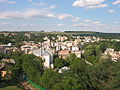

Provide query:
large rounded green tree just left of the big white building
left=23, top=55, right=43, bottom=82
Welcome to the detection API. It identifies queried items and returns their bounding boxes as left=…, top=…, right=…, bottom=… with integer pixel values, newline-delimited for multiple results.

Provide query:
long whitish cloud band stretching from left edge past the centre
left=0, top=9, right=80, bottom=21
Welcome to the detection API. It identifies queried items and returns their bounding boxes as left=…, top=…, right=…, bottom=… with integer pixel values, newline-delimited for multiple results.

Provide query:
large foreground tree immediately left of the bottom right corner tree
left=66, top=58, right=95, bottom=90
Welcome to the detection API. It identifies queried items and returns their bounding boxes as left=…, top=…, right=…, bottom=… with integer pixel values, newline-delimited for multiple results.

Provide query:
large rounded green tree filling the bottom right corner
left=93, top=60, right=120, bottom=90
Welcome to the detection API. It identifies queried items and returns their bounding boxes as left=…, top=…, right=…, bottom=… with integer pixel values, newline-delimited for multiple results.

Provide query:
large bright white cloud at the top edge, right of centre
left=73, top=0, right=107, bottom=9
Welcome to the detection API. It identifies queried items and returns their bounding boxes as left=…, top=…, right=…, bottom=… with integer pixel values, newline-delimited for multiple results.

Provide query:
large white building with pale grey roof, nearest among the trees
left=32, top=47, right=53, bottom=68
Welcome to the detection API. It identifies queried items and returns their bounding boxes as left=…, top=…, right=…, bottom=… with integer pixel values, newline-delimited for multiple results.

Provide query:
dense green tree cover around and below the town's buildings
left=0, top=34, right=120, bottom=90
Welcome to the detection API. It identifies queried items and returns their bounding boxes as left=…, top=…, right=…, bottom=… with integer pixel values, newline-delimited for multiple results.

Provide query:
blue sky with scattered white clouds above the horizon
left=0, top=0, right=120, bottom=33
